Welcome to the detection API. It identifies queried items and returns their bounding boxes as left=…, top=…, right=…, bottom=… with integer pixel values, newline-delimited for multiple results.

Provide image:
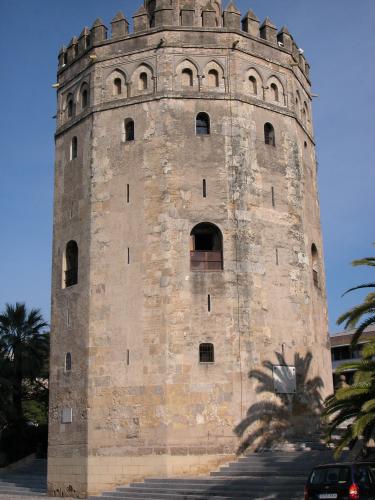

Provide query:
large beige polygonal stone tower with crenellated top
left=48, top=0, right=331, bottom=497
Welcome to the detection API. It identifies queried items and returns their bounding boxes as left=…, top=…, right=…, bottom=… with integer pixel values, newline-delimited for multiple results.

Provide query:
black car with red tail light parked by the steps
left=305, top=462, right=375, bottom=500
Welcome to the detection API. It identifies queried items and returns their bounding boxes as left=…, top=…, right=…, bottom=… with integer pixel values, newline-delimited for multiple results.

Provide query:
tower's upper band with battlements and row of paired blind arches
left=57, top=0, right=313, bottom=143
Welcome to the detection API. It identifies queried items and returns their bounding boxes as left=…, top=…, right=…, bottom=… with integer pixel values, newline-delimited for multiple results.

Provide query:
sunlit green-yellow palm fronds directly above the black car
left=323, top=342, right=375, bottom=457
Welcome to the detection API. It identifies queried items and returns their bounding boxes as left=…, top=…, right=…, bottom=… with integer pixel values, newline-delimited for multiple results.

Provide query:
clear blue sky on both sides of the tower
left=0, top=0, right=375, bottom=331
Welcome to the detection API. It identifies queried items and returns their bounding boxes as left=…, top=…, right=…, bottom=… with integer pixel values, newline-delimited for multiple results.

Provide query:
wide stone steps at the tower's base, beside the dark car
left=90, top=451, right=333, bottom=500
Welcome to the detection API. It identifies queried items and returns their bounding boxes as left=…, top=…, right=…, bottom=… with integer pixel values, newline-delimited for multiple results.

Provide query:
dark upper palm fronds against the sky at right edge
left=337, top=257, right=375, bottom=347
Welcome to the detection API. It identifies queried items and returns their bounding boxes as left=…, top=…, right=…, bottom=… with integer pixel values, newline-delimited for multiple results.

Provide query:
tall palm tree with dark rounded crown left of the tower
left=0, top=303, right=49, bottom=423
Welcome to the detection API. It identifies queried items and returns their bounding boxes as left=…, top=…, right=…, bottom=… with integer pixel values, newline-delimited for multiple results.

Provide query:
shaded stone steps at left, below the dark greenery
left=0, top=459, right=47, bottom=497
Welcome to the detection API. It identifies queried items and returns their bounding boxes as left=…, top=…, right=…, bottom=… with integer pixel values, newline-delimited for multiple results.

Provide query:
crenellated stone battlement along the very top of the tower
left=58, top=0, right=310, bottom=79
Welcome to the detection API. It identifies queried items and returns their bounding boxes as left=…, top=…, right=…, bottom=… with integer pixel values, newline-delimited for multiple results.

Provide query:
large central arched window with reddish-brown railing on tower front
left=190, top=222, right=223, bottom=271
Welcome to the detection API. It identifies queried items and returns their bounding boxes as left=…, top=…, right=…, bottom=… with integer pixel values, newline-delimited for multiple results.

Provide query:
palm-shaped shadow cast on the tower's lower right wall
left=234, top=352, right=324, bottom=454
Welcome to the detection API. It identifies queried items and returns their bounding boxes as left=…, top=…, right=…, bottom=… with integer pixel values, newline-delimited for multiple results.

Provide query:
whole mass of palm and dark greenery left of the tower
left=0, top=303, right=49, bottom=461
